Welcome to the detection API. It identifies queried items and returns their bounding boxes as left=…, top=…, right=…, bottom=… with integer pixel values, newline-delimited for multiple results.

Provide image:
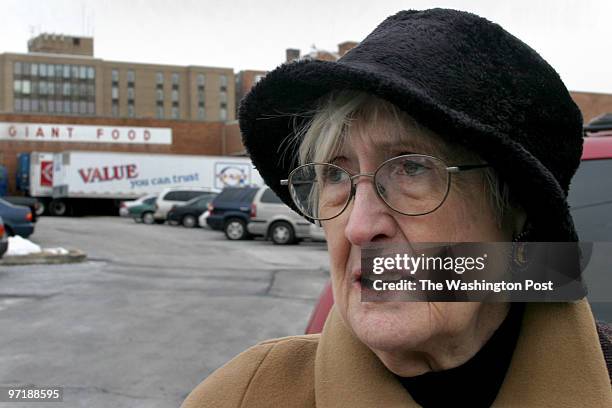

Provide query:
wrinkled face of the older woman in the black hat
left=322, top=111, right=512, bottom=372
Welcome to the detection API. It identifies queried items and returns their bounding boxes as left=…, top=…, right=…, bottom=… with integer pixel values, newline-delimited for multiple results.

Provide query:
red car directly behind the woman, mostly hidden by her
left=306, top=136, right=612, bottom=334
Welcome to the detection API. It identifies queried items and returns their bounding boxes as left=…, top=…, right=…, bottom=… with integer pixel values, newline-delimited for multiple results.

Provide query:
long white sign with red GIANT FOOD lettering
left=0, top=122, right=172, bottom=144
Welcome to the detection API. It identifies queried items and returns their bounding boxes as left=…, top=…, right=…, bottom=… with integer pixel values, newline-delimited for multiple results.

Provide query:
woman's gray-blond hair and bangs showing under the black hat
left=292, top=91, right=514, bottom=226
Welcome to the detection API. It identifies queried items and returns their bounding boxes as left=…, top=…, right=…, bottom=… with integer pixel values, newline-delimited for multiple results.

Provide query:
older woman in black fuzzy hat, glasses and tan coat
left=184, top=9, right=612, bottom=408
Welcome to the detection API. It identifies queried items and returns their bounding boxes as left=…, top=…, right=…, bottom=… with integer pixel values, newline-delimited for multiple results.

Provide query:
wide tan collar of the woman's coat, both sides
left=315, top=300, right=612, bottom=408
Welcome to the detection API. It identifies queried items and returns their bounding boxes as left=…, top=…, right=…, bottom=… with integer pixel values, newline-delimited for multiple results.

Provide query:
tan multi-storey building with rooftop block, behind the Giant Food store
left=0, top=34, right=236, bottom=122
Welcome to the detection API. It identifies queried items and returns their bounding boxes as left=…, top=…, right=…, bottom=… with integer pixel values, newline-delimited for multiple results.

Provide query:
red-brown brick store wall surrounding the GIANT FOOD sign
left=0, top=113, right=228, bottom=193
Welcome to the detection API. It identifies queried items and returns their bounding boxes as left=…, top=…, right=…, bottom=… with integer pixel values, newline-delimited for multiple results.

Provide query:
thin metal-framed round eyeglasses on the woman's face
left=281, top=154, right=489, bottom=221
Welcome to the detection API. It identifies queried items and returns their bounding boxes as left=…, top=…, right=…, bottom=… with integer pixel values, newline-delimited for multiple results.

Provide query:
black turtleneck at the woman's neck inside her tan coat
left=397, top=303, right=524, bottom=408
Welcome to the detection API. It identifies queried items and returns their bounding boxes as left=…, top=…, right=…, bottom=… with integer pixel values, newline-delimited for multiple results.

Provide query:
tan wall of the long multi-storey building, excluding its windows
left=0, top=53, right=236, bottom=121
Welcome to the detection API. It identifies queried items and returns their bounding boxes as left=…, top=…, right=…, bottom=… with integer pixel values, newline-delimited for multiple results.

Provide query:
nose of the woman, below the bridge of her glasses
left=344, top=177, right=396, bottom=246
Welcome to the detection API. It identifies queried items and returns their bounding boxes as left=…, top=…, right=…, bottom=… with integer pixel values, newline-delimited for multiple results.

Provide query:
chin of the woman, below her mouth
left=345, top=299, right=433, bottom=351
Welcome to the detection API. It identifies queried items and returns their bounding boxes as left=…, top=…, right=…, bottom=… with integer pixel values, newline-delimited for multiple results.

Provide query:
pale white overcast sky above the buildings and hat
left=0, top=0, right=612, bottom=93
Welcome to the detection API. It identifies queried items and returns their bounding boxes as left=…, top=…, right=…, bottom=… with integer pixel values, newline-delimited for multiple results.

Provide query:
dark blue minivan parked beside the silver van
left=206, top=187, right=259, bottom=240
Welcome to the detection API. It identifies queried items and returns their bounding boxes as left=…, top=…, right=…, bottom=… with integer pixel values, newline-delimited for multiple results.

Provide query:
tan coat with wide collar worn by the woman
left=183, top=301, right=612, bottom=408
